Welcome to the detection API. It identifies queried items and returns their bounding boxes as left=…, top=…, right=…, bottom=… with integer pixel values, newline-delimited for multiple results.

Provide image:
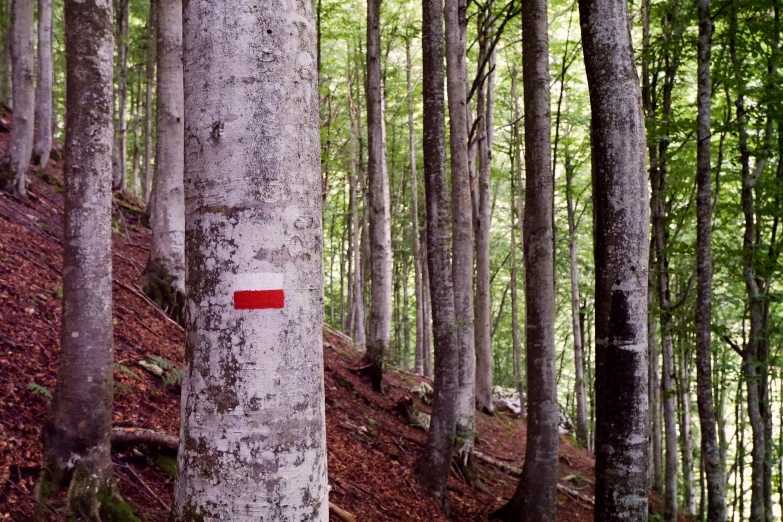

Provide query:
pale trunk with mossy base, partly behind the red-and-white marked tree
left=144, top=0, right=185, bottom=323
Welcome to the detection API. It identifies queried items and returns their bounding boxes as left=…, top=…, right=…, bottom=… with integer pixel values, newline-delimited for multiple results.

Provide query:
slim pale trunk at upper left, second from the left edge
left=33, top=0, right=52, bottom=167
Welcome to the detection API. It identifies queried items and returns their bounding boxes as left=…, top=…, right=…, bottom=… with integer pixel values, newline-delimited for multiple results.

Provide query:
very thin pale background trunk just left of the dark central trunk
left=405, top=38, right=425, bottom=375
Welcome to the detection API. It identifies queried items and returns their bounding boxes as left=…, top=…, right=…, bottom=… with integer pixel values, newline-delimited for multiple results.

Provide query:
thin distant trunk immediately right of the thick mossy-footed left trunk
left=112, top=0, right=130, bottom=190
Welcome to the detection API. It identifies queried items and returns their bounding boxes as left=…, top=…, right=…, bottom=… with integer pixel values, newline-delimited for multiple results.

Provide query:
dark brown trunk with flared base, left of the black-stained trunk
left=496, top=0, right=560, bottom=522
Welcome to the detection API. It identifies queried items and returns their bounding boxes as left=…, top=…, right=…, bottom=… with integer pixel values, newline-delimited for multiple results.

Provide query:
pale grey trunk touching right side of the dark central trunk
left=448, top=0, right=476, bottom=464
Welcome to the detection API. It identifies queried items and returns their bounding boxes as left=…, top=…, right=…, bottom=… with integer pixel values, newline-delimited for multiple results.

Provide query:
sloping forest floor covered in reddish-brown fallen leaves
left=0, top=114, right=680, bottom=522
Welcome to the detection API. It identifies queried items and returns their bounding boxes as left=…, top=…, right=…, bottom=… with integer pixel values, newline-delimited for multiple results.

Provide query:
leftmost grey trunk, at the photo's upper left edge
left=0, top=0, right=35, bottom=199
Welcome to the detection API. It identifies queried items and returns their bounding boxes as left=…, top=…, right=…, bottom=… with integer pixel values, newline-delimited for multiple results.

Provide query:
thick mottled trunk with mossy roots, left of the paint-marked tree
left=39, top=0, right=121, bottom=520
